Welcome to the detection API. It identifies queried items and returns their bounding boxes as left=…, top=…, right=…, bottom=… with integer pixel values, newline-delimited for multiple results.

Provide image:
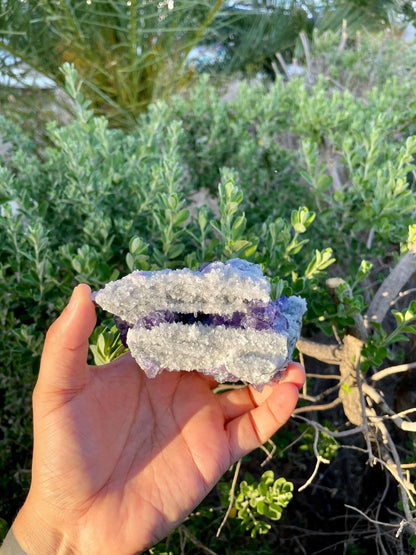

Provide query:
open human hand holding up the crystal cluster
left=13, top=285, right=304, bottom=555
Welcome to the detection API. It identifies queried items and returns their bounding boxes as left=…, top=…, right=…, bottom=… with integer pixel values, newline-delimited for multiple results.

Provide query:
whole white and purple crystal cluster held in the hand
left=94, top=259, right=306, bottom=390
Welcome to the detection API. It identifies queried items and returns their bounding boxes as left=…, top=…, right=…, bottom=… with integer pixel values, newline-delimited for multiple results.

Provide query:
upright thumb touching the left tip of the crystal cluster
left=36, top=284, right=96, bottom=396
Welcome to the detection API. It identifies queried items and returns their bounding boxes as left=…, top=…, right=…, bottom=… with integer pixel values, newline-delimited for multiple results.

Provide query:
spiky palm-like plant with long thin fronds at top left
left=0, top=0, right=228, bottom=126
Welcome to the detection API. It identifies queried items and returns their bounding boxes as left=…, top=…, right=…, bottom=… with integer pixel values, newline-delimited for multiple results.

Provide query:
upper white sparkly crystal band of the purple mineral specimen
left=95, top=259, right=270, bottom=324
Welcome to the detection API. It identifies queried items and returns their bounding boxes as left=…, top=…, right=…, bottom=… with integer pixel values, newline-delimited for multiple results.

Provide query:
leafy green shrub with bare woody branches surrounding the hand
left=0, top=2, right=416, bottom=555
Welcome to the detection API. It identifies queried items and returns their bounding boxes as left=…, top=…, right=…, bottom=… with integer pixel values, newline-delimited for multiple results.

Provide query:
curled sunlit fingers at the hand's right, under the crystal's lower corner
left=223, top=363, right=305, bottom=461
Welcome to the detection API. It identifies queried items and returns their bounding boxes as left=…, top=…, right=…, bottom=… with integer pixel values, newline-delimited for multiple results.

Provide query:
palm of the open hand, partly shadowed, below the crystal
left=36, top=355, right=231, bottom=553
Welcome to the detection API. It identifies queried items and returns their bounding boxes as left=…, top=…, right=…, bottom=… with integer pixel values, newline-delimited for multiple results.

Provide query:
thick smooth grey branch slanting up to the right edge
left=364, top=242, right=416, bottom=328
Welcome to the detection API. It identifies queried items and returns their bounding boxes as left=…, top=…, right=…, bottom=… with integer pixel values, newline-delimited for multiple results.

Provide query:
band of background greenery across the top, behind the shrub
left=0, top=0, right=415, bottom=128
